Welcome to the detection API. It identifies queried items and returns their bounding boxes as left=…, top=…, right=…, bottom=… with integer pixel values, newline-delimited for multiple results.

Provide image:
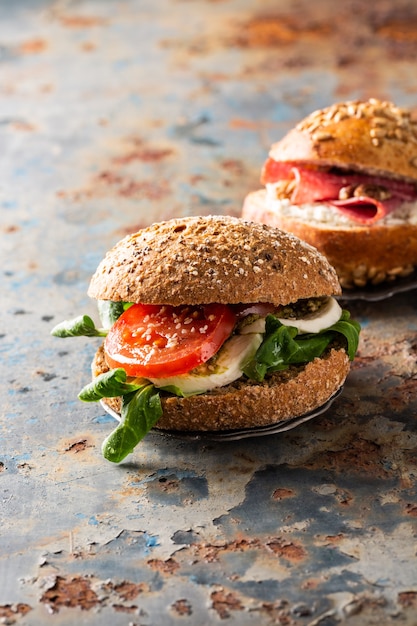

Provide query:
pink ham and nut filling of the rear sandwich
left=261, top=157, right=417, bottom=225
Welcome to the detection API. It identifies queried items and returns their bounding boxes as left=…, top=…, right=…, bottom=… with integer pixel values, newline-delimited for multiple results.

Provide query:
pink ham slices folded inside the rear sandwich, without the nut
left=261, top=158, right=417, bottom=224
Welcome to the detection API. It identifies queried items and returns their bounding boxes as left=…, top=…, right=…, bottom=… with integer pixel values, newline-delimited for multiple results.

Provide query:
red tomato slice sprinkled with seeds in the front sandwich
left=104, top=304, right=236, bottom=378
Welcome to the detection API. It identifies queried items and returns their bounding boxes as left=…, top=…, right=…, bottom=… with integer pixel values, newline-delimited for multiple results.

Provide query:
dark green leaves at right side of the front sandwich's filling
left=243, top=310, right=360, bottom=382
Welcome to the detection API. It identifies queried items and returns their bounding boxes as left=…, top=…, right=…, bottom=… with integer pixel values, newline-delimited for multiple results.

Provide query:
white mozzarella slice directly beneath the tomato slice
left=149, top=333, right=262, bottom=395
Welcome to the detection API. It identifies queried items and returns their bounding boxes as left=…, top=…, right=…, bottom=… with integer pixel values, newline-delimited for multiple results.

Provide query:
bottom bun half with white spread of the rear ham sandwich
left=242, top=189, right=417, bottom=289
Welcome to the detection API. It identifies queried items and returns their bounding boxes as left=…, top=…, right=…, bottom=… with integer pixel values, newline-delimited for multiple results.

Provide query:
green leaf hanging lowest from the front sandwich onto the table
left=101, top=384, right=162, bottom=463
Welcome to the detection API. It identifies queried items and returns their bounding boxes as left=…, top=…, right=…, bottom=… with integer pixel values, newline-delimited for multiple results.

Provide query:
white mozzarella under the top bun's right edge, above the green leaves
left=241, top=298, right=342, bottom=334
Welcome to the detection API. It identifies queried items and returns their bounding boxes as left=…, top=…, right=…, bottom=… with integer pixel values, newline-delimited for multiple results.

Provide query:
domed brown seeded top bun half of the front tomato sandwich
left=88, top=215, right=341, bottom=306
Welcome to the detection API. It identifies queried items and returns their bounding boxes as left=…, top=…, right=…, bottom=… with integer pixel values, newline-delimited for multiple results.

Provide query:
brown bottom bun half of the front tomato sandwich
left=92, top=347, right=350, bottom=432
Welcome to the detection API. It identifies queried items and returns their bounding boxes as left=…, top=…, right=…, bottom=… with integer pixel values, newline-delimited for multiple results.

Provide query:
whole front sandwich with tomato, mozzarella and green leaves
left=52, top=216, right=359, bottom=462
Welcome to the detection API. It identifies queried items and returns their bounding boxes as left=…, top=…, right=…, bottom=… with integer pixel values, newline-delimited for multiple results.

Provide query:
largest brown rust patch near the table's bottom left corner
left=40, top=576, right=100, bottom=613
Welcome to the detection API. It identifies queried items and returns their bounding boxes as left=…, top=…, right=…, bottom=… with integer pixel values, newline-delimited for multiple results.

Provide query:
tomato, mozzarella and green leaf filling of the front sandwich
left=52, top=297, right=360, bottom=462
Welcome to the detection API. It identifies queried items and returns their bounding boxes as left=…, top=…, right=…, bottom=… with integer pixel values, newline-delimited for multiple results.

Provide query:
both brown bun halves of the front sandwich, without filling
left=88, top=216, right=349, bottom=431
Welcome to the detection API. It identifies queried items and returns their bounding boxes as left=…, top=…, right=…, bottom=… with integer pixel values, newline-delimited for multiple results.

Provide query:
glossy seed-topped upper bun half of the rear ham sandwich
left=269, top=99, right=417, bottom=181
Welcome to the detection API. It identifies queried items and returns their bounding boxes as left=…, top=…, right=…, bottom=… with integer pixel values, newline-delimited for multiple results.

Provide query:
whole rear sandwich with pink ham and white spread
left=242, top=99, right=417, bottom=289
